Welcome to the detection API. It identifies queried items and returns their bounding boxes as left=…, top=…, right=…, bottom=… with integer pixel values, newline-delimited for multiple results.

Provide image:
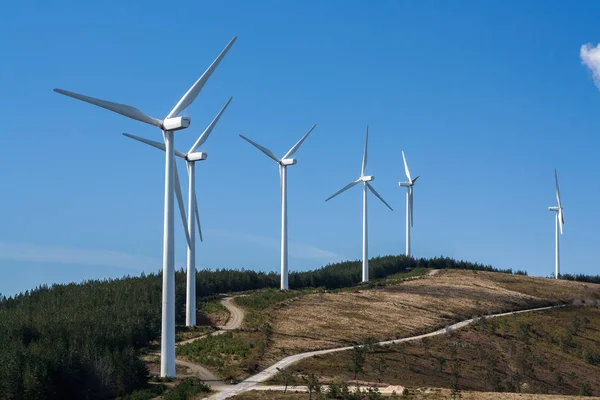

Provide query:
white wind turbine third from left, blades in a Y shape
left=240, top=124, right=317, bottom=290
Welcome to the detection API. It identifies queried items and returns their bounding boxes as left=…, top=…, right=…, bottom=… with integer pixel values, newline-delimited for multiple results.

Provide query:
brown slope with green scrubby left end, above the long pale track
left=178, top=269, right=600, bottom=379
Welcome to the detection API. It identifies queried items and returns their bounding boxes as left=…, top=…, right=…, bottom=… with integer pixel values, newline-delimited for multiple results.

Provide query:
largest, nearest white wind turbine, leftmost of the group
left=54, top=36, right=237, bottom=377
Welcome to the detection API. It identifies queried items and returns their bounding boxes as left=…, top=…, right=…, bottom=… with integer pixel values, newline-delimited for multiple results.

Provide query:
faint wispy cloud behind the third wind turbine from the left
left=210, top=230, right=346, bottom=261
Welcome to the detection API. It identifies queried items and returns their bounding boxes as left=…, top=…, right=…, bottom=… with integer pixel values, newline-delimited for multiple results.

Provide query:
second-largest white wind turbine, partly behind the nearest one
left=123, top=97, right=232, bottom=326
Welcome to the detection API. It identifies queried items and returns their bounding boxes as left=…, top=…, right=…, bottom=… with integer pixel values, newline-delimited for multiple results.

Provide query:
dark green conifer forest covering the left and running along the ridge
left=0, top=256, right=556, bottom=399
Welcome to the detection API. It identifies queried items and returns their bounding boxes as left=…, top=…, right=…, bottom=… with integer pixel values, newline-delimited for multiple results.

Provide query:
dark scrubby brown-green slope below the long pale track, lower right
left=274, top=306, right=600, bottom=395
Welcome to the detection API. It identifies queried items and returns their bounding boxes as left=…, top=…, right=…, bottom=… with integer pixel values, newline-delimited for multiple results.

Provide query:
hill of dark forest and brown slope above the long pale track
left=0, top=256, right=598, bottom=399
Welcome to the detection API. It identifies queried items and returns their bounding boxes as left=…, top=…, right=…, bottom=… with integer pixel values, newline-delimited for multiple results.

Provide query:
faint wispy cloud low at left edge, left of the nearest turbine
left=0, top=242, right=162, bottom=271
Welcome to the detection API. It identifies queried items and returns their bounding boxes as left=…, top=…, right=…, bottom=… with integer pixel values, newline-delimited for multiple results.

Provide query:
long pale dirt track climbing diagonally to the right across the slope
left=205, top=306, right=564, bottom=400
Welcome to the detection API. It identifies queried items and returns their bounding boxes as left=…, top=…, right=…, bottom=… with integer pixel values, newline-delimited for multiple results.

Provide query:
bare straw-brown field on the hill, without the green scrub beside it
left=266, top=270, right=600, bottom=362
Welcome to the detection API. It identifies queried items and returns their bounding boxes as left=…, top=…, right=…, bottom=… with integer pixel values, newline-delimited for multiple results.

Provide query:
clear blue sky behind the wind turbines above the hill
left=0, top=0, right=600, bottom=294
